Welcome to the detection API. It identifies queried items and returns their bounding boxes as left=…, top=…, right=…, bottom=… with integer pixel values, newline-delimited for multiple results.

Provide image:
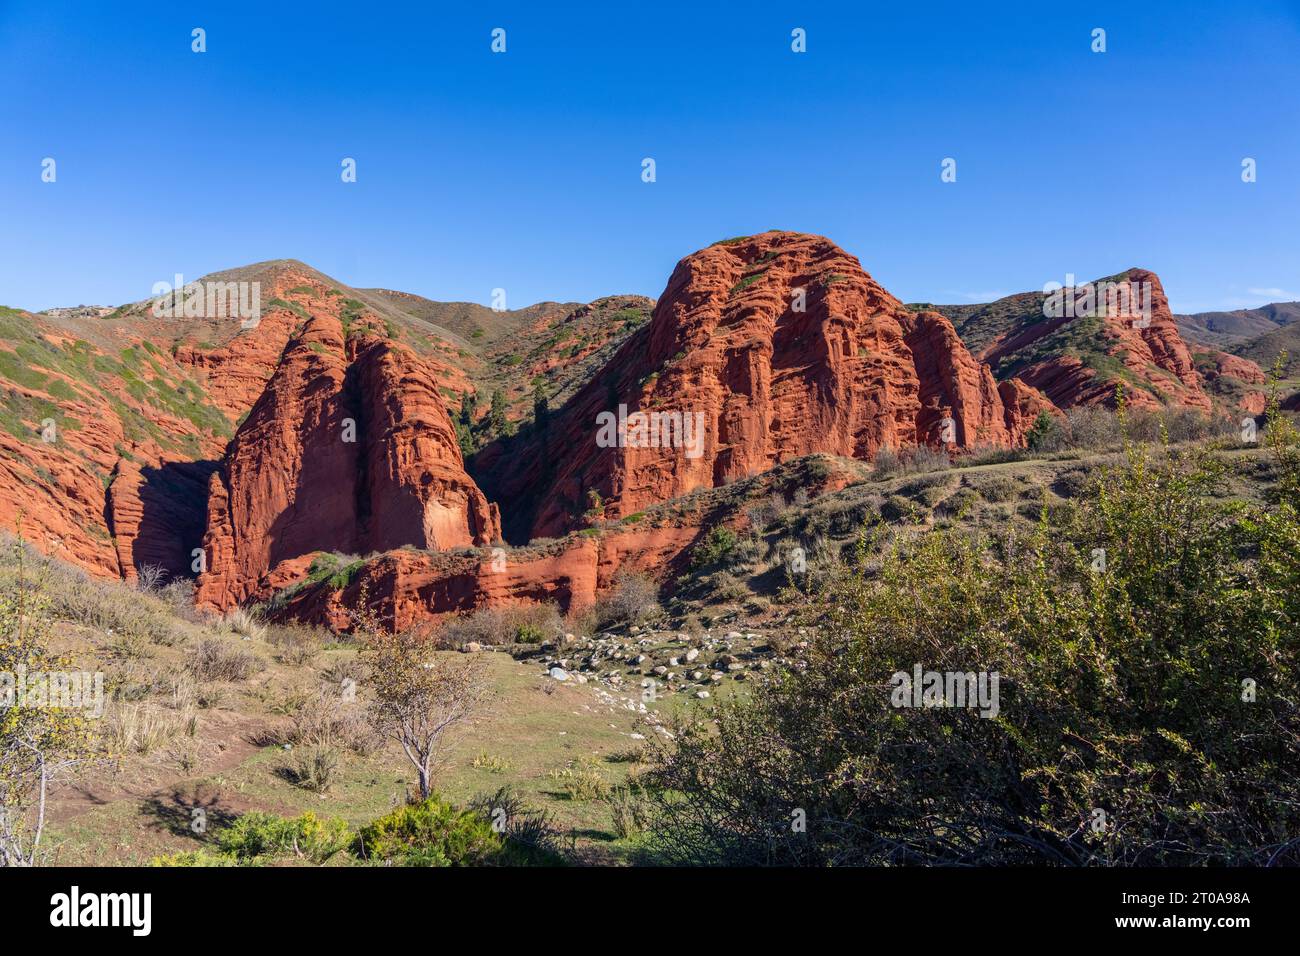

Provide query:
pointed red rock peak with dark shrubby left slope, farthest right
left=980, top=269, right=1210, bottom=412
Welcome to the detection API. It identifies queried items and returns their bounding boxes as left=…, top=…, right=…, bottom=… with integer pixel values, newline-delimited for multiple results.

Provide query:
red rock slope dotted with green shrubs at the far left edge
left=0, top=313, right=225, bottom=579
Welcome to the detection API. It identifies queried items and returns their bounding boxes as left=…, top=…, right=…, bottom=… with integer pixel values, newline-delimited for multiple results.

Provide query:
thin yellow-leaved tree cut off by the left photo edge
left=0, top=537, right=95, bottom=866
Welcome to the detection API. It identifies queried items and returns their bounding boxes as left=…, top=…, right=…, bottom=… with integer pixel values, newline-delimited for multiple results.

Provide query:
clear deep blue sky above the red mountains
left=0, top=0, right=1300, bottom=311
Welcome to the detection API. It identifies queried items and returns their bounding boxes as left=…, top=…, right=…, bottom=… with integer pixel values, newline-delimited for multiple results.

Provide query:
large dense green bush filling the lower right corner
left=653, top=427, right=1300, bottom=865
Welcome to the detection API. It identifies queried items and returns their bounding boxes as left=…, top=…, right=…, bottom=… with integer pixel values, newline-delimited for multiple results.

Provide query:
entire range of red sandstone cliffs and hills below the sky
left=0, top=230, right=1266, bottom=630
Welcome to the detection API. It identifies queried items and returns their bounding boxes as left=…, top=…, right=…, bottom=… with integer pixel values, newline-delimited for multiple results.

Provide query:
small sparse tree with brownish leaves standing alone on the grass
left=367, top=631, right=488, bottom=800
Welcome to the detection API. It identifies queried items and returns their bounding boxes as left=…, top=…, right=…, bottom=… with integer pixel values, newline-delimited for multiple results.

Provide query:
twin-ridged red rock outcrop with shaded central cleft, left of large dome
left=198, top=315, right=499, bottom=609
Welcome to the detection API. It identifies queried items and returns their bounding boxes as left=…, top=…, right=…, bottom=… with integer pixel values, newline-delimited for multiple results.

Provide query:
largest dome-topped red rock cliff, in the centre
left=473, top=232, right=1048, bottom=540
